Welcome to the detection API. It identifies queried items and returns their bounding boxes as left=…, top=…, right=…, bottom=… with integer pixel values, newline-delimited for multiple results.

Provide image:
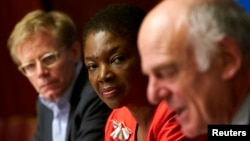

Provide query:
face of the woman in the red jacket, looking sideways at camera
left=84, top=31, right=147, bottom=108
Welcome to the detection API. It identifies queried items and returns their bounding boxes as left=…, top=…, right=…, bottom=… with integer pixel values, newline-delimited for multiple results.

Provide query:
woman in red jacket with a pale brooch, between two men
left=83, top=4, right=206, bottom=141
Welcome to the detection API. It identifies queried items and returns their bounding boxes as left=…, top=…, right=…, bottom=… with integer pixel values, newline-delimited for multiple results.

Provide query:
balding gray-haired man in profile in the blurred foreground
left=138, top=0, right=250, bottom=138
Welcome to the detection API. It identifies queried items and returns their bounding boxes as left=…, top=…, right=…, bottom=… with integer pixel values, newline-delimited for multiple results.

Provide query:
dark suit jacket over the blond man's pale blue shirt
left=33, top=67, right=111, bottom=141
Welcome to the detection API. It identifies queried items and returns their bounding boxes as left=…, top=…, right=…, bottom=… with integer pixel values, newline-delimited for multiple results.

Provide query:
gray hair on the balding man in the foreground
left=188, top=0, right=250, bottom=71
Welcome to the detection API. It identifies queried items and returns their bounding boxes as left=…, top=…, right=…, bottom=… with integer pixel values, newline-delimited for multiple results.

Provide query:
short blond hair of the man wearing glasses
left=7, top=10, right=77, bottom=64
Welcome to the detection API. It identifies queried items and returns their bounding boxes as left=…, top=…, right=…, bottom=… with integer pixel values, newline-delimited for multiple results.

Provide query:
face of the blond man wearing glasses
left=17, top=32, right=76, bottom=100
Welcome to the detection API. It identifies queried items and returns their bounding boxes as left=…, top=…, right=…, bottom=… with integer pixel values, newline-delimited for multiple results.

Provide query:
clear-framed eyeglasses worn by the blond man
left=18, top=47, right=66, bottom=77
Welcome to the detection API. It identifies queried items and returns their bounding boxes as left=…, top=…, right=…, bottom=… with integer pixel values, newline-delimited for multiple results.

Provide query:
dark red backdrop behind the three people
left=0, top=0, right=160, bottom=141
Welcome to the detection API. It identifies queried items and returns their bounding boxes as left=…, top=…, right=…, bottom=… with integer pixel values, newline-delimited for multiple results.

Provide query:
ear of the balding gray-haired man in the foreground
left=219, top=37, right=242, bottom=79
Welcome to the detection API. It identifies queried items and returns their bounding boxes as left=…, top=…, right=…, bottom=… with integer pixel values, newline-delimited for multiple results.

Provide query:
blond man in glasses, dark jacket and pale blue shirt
left=8, top=10, right=110, bottom=141
